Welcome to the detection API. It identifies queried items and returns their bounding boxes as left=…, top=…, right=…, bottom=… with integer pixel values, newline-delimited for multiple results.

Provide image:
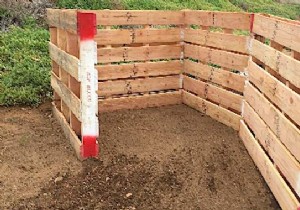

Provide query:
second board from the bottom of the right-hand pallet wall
left=243, top=103, right=300, bottom=196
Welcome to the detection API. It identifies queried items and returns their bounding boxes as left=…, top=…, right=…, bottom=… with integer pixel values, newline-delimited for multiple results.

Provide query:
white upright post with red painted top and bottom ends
left=77, top=12, right=99, bottom=158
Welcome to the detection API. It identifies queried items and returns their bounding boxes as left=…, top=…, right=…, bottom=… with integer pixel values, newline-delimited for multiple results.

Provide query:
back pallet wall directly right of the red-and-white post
left=94, top=10, right=184, bottom=112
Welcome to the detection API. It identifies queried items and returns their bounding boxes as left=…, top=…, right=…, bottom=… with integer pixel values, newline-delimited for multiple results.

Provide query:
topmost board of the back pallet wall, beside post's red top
left=84, top=10, right=184, bottom=26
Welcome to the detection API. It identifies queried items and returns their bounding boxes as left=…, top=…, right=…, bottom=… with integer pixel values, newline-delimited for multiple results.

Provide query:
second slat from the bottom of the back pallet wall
left=98, top=75, right=180, bottom=96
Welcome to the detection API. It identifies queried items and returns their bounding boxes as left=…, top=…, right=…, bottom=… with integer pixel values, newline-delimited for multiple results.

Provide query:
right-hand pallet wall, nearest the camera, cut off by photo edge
left=240, top=14, right=300, bottom=209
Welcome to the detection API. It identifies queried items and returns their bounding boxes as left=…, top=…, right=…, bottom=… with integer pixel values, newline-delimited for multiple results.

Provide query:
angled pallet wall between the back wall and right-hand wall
left=183, top=11, right=251, bottom=130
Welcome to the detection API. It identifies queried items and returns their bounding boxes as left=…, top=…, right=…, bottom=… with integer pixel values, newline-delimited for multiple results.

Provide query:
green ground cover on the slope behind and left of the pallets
left=0, top=0, right=300, bottom=105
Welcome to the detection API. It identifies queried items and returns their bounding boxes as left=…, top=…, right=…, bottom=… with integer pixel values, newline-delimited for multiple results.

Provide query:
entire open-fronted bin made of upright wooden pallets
left=47, top=9, right=300, bottom=209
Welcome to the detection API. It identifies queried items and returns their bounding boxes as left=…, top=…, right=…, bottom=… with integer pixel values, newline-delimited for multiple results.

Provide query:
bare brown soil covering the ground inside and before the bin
left=0, top=104, right=279, bottom=210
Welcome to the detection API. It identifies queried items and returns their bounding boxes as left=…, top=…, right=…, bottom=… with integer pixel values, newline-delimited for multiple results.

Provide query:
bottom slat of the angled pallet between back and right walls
left=182, top=90, right=241, bottom=130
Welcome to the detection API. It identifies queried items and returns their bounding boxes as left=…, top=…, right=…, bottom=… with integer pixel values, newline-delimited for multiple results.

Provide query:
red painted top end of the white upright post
left=77, top=12, right=97, bottom=41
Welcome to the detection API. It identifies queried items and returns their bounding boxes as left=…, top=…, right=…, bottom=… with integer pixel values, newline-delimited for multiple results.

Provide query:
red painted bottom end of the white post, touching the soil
left=80, top=136, right=99, bottom=158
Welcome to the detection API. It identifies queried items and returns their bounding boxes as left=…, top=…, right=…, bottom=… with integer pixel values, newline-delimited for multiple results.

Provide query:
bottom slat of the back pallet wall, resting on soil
left=99, top=91, right=182, bottom=113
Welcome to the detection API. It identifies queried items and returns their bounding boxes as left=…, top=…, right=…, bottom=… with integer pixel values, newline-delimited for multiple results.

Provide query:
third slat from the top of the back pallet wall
left=98, top=45, right=181, bottom=63
